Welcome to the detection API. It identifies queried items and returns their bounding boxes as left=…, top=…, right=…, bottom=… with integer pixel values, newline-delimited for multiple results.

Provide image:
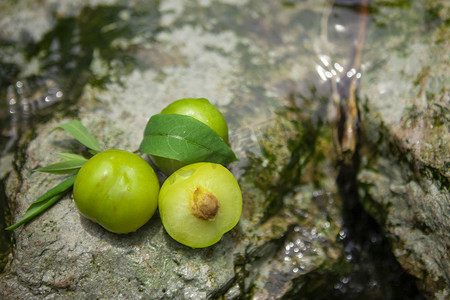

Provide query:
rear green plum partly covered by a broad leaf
left=152, top=98, right=228, bottom=175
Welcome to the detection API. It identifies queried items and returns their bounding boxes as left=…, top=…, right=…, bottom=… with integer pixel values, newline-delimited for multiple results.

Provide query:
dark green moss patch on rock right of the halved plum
left=241, top=95, right=332, bottom=222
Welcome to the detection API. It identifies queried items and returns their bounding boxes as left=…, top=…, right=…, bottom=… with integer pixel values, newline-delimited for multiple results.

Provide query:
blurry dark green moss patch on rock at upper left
left=25, top=1, right=159, bottom=88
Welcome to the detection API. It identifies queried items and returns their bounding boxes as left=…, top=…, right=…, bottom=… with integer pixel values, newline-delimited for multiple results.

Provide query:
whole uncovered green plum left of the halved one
left=73, top=149, right=159, bottom=233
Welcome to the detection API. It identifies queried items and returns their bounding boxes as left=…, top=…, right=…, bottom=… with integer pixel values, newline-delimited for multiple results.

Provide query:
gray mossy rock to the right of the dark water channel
left=358, top=2, right=450, bottom=299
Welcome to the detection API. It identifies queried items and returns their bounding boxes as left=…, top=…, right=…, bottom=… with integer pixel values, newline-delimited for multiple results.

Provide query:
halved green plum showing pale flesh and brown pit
left=158, top=162, right=242, bottom=248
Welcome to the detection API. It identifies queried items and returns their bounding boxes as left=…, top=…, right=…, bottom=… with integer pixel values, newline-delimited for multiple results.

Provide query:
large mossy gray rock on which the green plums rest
left=0, top=1, right=341, bottom=299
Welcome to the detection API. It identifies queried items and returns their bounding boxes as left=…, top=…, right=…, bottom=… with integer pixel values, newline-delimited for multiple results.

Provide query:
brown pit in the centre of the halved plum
left=191, top=187, right=220, bottom=221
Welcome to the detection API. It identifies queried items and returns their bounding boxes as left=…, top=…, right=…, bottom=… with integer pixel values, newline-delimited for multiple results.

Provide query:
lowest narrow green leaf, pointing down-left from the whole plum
left=6, top=175, right=77, bottom=230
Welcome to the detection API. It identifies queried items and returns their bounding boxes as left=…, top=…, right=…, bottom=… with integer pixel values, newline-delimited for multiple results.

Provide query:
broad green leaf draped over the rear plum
left=139, top=114, right=237, bottom=164
